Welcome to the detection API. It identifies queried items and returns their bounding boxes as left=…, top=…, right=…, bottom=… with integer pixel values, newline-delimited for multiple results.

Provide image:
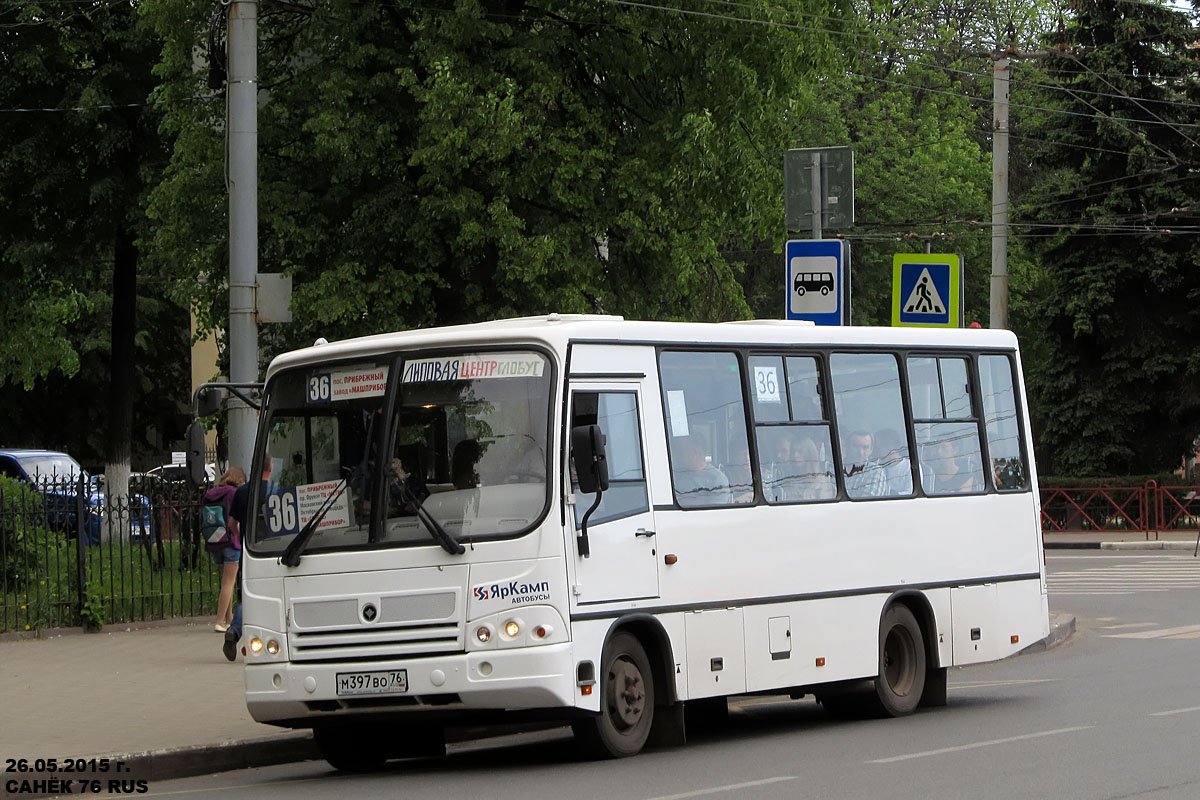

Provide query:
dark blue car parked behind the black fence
left=0, top=450, right=152, bottom=545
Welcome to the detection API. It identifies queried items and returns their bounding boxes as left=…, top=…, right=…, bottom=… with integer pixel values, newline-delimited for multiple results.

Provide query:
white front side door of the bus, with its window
left=566, top=381, right=659, bottom=606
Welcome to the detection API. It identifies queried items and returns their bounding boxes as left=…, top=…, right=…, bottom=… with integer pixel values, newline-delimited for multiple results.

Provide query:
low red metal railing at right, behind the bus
left=1042, top=481, right=1200, bottom=539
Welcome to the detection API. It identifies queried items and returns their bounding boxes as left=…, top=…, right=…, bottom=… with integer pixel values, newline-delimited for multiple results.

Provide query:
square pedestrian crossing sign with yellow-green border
left=892, top=253, right=962, bottom=327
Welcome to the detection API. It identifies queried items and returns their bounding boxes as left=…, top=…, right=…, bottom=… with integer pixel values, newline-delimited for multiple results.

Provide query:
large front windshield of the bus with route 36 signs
left=253, top=351, right=552, bottom=554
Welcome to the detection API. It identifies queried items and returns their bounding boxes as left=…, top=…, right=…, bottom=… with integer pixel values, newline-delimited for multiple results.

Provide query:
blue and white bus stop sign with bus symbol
left=784, top=239, right=850, bottom=325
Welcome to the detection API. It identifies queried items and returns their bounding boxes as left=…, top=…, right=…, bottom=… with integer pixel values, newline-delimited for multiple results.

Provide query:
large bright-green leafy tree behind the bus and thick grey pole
left=150, top=0, right=846, bottom=350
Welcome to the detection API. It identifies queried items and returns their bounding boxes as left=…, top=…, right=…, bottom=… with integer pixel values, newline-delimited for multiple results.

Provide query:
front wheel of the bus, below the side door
left=572, top=632, right=654, bottom=758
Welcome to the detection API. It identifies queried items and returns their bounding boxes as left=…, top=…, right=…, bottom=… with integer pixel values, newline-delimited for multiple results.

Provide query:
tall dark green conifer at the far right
left=1020, top=0, right=1200, bottom=475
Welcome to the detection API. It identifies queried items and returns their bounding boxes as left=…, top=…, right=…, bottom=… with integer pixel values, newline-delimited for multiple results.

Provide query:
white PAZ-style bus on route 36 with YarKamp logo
left=229, top=314, right=1049, bottom=769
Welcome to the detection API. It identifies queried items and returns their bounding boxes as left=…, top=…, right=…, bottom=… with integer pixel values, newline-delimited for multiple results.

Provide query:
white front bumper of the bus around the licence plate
left=246, top=642, right=577, bottom=727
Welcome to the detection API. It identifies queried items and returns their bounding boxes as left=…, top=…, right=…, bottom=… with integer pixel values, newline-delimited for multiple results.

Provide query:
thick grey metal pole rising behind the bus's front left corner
left=227, top=0, right=259, bottom=480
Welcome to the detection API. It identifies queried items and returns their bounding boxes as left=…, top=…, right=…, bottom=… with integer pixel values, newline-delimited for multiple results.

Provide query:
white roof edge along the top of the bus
left=268, top=314, right=1016, bottom=375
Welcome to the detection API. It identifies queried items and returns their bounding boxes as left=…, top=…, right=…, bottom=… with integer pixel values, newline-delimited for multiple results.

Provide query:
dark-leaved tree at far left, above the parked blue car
left=0, top=2, right=186, bottom=494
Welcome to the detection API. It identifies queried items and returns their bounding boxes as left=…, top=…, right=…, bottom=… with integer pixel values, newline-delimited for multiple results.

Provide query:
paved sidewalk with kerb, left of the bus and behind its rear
left=0, top=606, right=1075, bottom=796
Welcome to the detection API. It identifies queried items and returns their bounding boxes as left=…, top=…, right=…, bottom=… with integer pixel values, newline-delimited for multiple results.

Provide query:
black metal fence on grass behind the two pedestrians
left=0, top=477, right=221, bottom=633
